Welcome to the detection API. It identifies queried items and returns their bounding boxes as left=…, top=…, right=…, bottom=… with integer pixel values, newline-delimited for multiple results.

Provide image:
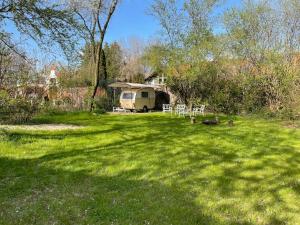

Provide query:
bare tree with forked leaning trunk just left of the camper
left=70, top=0, right=120, bottom=110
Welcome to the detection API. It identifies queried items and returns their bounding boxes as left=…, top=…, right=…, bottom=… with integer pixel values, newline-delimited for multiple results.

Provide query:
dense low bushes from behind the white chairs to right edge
left=168, top=60, right=300, bottom=119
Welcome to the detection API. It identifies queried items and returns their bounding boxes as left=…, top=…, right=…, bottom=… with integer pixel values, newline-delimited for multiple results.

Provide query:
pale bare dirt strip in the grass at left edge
left=0, top=124, right=83, bottom=131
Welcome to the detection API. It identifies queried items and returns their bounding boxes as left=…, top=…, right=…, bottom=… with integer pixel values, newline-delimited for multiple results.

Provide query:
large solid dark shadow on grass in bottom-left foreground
left=0, top=158, right=217, bottom=225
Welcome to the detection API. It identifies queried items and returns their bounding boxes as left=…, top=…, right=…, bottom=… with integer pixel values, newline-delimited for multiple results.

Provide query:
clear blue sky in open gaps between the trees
left=7, top=0, right=241, bottom=66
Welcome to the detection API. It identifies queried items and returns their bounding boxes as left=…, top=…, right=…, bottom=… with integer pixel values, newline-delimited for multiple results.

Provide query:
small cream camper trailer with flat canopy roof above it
left=109, top=83, right=159, bottom=112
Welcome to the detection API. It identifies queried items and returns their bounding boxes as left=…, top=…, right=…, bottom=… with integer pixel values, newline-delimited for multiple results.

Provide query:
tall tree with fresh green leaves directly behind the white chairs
left=151, top=0, right=219, bottom=103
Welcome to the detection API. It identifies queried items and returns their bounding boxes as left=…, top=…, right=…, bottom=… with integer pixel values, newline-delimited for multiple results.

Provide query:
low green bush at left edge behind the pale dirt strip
left=0, top=91, right=38, bottom=124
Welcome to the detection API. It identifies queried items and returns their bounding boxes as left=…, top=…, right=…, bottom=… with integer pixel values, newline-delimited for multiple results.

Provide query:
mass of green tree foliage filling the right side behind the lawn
left=148, top=0, right=300, bottom=115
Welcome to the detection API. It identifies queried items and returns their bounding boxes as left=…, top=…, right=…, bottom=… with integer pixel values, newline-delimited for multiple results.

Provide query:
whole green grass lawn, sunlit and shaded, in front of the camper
left=0, top=113, right=300, bottom=225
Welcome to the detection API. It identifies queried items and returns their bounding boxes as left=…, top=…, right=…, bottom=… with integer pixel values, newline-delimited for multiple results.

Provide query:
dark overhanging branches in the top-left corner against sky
left=0, top=0, right=75, bottom=57
